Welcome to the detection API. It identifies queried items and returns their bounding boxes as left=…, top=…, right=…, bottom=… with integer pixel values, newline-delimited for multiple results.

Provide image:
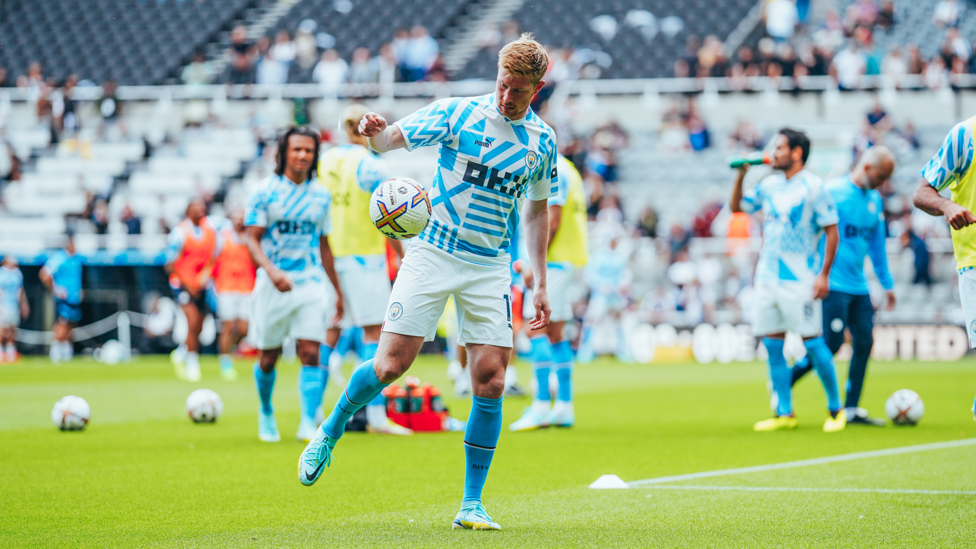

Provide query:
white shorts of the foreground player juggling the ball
left=383, top=242, right=512, bottom=347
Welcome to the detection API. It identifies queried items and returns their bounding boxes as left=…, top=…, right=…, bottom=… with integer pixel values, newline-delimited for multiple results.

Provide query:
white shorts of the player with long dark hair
left=250, top=272, right=328, bottom=350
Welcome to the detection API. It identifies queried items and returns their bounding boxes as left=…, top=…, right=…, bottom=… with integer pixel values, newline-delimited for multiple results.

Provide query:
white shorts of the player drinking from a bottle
left=752, top=282, right=823, bottom=338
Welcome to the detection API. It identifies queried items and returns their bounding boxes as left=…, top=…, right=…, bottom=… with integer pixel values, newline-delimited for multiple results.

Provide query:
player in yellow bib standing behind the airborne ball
left=318, top=103, right=413, bottom=440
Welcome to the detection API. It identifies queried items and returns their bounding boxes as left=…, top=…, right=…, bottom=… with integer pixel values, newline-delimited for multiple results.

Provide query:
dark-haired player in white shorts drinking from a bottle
left=730, top=128, right=847, bottom=432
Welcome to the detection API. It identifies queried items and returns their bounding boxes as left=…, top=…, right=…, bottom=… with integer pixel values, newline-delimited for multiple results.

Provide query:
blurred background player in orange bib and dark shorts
left=166, top=197, right=220, bottom=382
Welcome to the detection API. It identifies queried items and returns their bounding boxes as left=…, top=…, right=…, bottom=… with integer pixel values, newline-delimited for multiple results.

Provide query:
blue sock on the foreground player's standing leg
left=461, top=396, right=504, bottom=506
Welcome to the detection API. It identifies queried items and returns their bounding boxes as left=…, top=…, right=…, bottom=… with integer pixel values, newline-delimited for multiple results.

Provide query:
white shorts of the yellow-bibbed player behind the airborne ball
left=325, top=255, right=391, bottom=328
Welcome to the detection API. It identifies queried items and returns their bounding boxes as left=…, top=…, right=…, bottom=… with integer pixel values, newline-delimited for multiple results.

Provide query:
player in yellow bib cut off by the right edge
left=913, top=116, right=976, bottom=348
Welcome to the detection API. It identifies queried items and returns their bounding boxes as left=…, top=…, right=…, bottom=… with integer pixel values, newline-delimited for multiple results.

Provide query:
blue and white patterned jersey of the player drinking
left=741, top=170, right=837, bottom=283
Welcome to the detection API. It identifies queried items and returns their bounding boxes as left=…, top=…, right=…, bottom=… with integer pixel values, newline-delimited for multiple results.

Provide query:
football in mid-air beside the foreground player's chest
left=369, top=177, right=430, bottom=240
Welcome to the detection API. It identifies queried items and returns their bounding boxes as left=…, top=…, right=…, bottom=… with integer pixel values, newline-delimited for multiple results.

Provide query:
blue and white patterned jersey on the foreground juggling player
left=396, top=94, right=558, bottom=265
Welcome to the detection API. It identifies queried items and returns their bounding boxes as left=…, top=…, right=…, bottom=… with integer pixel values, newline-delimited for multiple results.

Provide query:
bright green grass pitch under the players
left=0, top=357, right=976, bottom=548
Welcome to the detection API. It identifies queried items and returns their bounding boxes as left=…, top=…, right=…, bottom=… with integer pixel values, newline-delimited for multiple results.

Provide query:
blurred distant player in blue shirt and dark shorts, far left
left=40, top=234, right=82, bottom=362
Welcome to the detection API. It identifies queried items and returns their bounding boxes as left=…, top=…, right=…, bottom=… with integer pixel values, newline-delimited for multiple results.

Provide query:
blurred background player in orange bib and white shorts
left=213, top=211, right=257, bottom=381
